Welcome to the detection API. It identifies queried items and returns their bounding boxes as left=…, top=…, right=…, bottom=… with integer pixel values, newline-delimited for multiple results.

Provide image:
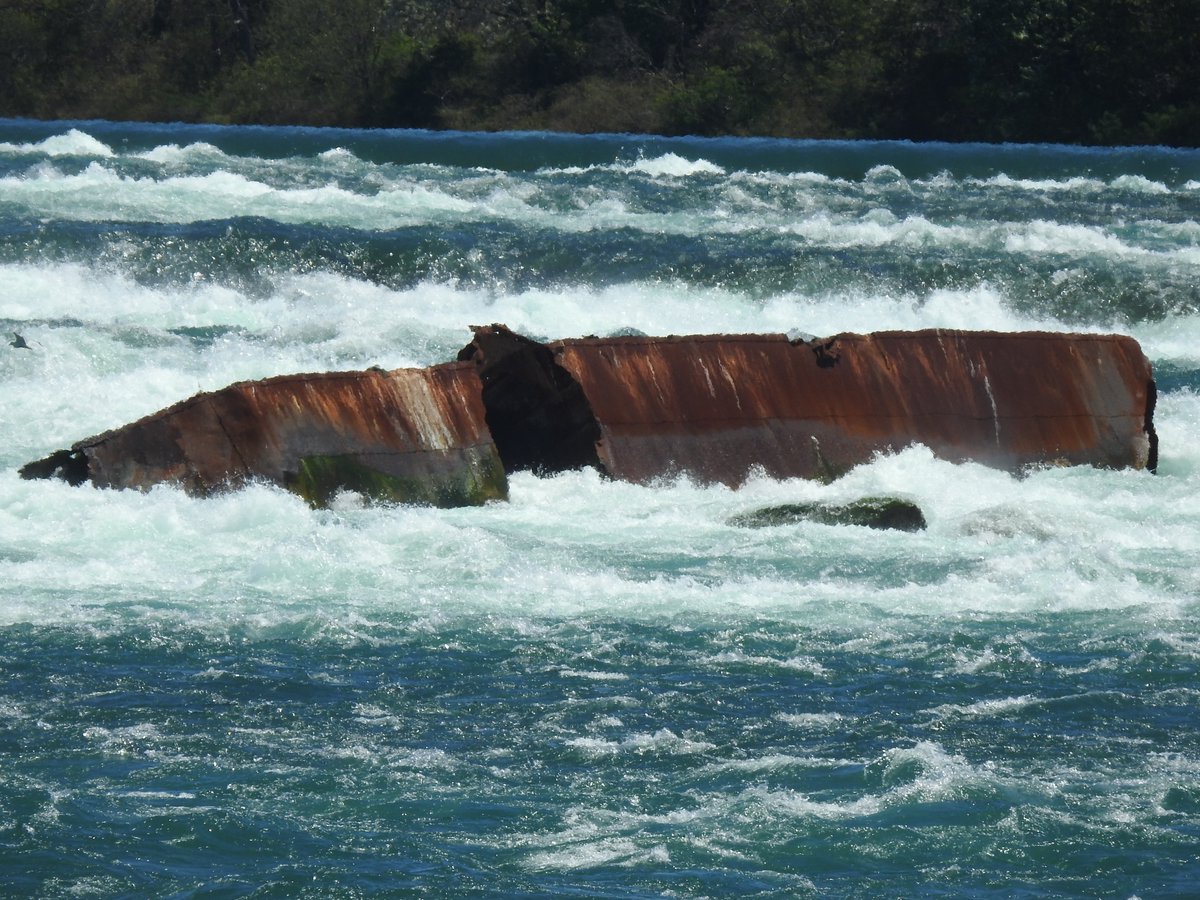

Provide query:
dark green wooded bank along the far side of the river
left=0, top=0, right=1200, bottom=146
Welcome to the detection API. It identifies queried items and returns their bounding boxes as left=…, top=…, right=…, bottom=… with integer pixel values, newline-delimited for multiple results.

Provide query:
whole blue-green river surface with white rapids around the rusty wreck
left=0, top=120, right=1200, bottom=900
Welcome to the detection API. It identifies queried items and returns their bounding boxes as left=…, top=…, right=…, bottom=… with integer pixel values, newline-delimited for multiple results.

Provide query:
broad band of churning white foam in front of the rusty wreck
left=0, top=427, right=1200, bottom=633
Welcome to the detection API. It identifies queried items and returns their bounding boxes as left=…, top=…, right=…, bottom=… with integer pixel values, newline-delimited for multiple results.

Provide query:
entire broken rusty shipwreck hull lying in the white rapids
left=22, top=325, right=1157, bottom=506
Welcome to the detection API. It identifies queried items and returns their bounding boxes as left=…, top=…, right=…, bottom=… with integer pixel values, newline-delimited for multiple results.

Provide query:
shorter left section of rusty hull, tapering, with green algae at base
left=23, top=364, right=506, bottom=506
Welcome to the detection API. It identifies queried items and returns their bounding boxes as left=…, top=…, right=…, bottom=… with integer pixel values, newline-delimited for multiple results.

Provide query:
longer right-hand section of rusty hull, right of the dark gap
left=551, top=330, right=1157, bottom=485
